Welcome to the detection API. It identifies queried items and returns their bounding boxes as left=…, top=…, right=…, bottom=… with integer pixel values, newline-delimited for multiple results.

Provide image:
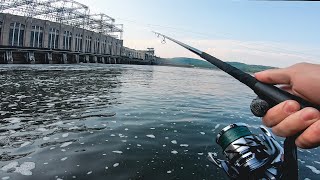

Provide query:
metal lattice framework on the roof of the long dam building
left=0, top=0, right=123, bottom=39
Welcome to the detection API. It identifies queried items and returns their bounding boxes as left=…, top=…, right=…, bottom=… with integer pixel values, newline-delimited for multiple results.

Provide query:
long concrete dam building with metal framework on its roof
left=0, top=0, right=157, bottom=64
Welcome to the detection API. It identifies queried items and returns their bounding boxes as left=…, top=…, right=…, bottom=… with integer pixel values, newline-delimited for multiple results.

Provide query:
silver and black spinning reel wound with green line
left=208, top=123, right=284, bottom=180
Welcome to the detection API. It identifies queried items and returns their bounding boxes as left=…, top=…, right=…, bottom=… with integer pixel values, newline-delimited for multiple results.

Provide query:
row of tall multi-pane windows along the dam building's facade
left=0, top=21, right=120, bottom=54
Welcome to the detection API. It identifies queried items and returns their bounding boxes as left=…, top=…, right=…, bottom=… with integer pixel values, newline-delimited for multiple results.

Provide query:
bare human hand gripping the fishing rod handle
left=255, top=63, right=320, bottom=148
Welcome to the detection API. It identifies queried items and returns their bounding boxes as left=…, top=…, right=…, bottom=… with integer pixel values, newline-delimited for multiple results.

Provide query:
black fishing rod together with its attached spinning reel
left=153, top=31, right=320, bottom=179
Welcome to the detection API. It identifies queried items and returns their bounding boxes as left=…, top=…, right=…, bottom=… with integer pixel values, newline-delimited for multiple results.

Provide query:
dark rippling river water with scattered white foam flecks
left=0, top=64, right=320, bottom=180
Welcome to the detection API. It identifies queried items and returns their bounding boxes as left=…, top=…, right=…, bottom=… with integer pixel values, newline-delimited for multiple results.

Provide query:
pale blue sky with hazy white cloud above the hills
left=77, top=0, right=320, bottom=67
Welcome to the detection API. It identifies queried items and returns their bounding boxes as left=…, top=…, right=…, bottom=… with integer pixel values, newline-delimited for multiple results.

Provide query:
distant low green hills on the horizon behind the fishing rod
left=158, top=57, right=274, bottom=73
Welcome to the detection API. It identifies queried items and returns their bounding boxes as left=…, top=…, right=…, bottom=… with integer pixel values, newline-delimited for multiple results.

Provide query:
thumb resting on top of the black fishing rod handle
left=254, top=68, right=291, bottom=84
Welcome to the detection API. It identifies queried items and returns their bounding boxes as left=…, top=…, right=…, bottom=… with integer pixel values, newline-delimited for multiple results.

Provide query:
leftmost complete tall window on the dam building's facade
left=9, top=22, right=25, bottom=46
